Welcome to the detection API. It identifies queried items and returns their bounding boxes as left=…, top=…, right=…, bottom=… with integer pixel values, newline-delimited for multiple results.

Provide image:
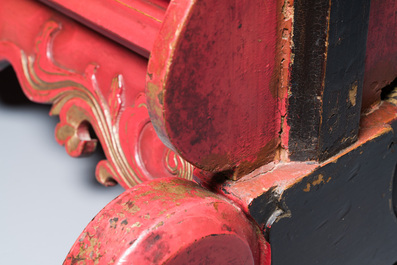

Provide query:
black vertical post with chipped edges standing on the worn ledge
left=288, top=0, right=370, bottom=160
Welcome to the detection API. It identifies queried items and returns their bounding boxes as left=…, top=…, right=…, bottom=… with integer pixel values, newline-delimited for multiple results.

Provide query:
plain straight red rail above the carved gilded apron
left=40, top=0, right=168, bottom=57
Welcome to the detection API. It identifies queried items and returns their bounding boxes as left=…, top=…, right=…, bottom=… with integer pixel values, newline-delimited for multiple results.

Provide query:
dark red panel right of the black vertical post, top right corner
left=362, top=0, right=397, bottom=110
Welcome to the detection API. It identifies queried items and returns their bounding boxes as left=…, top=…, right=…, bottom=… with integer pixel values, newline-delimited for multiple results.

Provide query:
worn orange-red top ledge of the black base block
left=200, top=101, right=397, bottom=214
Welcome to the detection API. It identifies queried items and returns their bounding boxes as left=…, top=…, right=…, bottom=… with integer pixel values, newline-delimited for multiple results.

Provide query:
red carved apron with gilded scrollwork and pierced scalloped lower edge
left=0, top=0, right=192, bottom=188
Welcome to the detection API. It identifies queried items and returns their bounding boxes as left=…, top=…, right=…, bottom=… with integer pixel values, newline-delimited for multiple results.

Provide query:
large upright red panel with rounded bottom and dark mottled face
left=146, top=0, right=284, bottom=177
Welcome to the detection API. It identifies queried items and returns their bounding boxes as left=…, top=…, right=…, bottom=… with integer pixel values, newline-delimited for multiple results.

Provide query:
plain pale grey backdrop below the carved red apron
left=0, top=68, right=123, bottom=265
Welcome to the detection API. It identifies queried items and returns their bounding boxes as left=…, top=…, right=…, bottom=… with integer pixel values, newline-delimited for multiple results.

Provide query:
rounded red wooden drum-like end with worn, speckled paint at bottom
left=64, top=178, right=270, bottom=265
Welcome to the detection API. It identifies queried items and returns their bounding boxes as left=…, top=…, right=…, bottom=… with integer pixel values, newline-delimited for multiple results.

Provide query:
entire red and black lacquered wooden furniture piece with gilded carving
left=0, top=0, right=397, bottom=265
